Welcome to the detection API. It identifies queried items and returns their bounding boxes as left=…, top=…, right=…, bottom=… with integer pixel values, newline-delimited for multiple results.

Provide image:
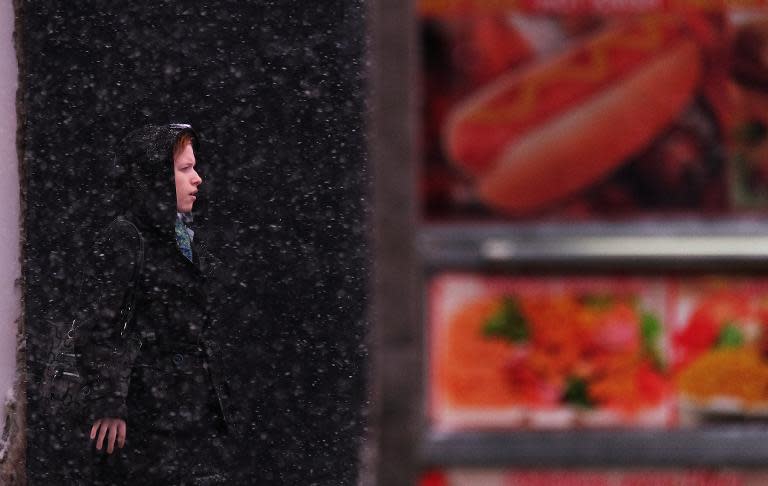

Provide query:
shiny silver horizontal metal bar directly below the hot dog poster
left=418, top=221, right=768, bottom=271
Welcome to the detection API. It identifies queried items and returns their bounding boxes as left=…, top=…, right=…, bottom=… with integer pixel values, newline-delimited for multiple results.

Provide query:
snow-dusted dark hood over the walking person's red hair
left=114, top=124, right=198, bottom=241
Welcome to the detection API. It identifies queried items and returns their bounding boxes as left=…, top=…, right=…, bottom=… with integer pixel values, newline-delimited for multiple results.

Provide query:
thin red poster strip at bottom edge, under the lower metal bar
left=419, top=469, right=768, bottom=486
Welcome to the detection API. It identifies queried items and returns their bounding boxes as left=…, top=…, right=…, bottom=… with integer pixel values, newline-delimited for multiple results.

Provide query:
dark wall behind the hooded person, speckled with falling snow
left=17, top=0, right=369, bottom=485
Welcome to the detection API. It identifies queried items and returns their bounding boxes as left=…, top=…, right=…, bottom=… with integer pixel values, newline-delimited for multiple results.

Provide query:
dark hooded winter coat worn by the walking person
left=76, top=125, right=242, bottom=434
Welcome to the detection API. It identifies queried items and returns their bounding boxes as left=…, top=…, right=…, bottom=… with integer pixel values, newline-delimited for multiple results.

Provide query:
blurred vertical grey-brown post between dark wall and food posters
left=362, top=0, right=423, bottom=486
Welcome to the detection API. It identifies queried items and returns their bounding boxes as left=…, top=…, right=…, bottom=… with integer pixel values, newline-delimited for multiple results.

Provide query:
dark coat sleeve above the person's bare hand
left=75, top=220, right=140, bottom=419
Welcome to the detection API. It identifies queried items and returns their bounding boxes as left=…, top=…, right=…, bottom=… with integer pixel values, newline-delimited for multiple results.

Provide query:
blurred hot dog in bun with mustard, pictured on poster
left=442, top=16, right=704, bottom=215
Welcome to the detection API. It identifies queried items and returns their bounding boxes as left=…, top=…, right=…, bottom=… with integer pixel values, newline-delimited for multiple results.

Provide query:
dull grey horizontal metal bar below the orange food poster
left=421, top=430, right=768, bottom=468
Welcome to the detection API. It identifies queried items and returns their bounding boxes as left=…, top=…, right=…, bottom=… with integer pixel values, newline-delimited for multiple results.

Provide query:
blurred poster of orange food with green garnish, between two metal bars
left=427, top=273, right=768, bottom=431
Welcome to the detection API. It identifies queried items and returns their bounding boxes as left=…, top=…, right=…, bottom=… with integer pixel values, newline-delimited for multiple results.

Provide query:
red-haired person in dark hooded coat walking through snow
left=76, top=124, right=240, bottom=484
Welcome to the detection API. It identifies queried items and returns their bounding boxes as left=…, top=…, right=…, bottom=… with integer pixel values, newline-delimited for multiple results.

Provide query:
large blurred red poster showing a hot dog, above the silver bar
left=419, top=9, right=768, bottom=222
